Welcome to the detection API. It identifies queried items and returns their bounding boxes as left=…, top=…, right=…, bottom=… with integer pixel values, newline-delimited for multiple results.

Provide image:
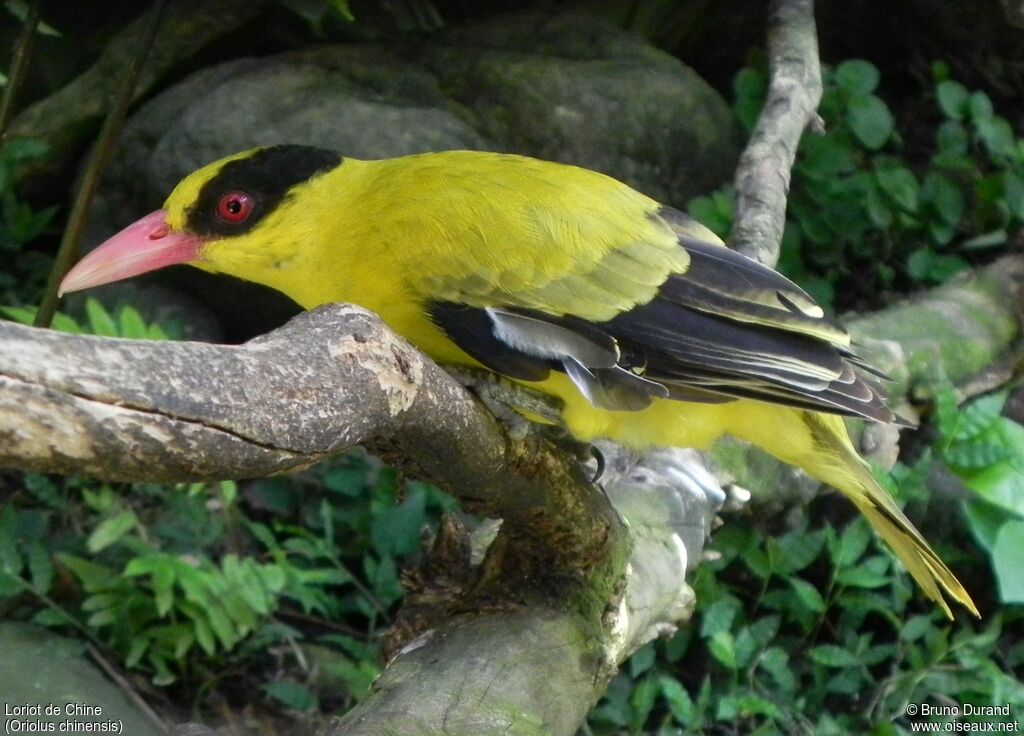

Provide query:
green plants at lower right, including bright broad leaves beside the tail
left=590, top=388, right=1024, bottom=736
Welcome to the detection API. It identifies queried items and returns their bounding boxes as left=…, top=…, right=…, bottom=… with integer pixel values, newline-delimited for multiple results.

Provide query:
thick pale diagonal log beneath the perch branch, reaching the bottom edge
left=321, top=444, right=723, bottom=736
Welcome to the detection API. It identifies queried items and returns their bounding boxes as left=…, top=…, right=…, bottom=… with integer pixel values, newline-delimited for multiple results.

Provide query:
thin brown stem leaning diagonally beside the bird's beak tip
left=35, top=0, right=167, bottom=328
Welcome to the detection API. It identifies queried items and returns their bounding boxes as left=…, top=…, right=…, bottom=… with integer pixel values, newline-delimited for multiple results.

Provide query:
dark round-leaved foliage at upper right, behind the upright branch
left=689, top=59, right=1024, bottom=304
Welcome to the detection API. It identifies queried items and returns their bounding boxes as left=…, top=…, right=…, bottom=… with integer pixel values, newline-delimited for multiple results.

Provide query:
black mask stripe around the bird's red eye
left=185, top=145, right=343, bottom=235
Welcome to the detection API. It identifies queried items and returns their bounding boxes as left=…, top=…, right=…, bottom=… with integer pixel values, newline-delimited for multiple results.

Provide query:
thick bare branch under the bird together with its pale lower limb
left=0, top=305, right=722, bottom=736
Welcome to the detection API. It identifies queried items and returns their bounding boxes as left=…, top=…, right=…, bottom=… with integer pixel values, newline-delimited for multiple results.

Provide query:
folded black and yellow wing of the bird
left=428, top=208, right=894, bottom=422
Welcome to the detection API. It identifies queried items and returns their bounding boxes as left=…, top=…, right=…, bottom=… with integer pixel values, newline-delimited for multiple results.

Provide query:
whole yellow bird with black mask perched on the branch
left=61, top=145, right=978, bottom=617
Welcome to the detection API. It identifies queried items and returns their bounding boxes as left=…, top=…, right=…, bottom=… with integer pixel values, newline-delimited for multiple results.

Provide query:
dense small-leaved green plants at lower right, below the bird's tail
left=591, top=507, right=1024, bottom=735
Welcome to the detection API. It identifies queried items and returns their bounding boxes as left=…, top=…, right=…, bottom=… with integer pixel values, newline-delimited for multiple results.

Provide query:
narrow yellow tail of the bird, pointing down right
left=801, top=412, right=981, bottom=619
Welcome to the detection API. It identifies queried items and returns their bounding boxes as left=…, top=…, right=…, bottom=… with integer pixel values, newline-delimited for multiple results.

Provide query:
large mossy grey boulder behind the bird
left=81, top=14, right=737, bottom=341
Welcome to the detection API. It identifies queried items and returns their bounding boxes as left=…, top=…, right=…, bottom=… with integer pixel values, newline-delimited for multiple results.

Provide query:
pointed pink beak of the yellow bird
left=57, top=210, right=203, bottom=296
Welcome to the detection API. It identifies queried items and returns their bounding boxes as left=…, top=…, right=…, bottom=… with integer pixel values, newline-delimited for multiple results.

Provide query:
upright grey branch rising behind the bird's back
left=729, top=0, right=821, bottom=266
